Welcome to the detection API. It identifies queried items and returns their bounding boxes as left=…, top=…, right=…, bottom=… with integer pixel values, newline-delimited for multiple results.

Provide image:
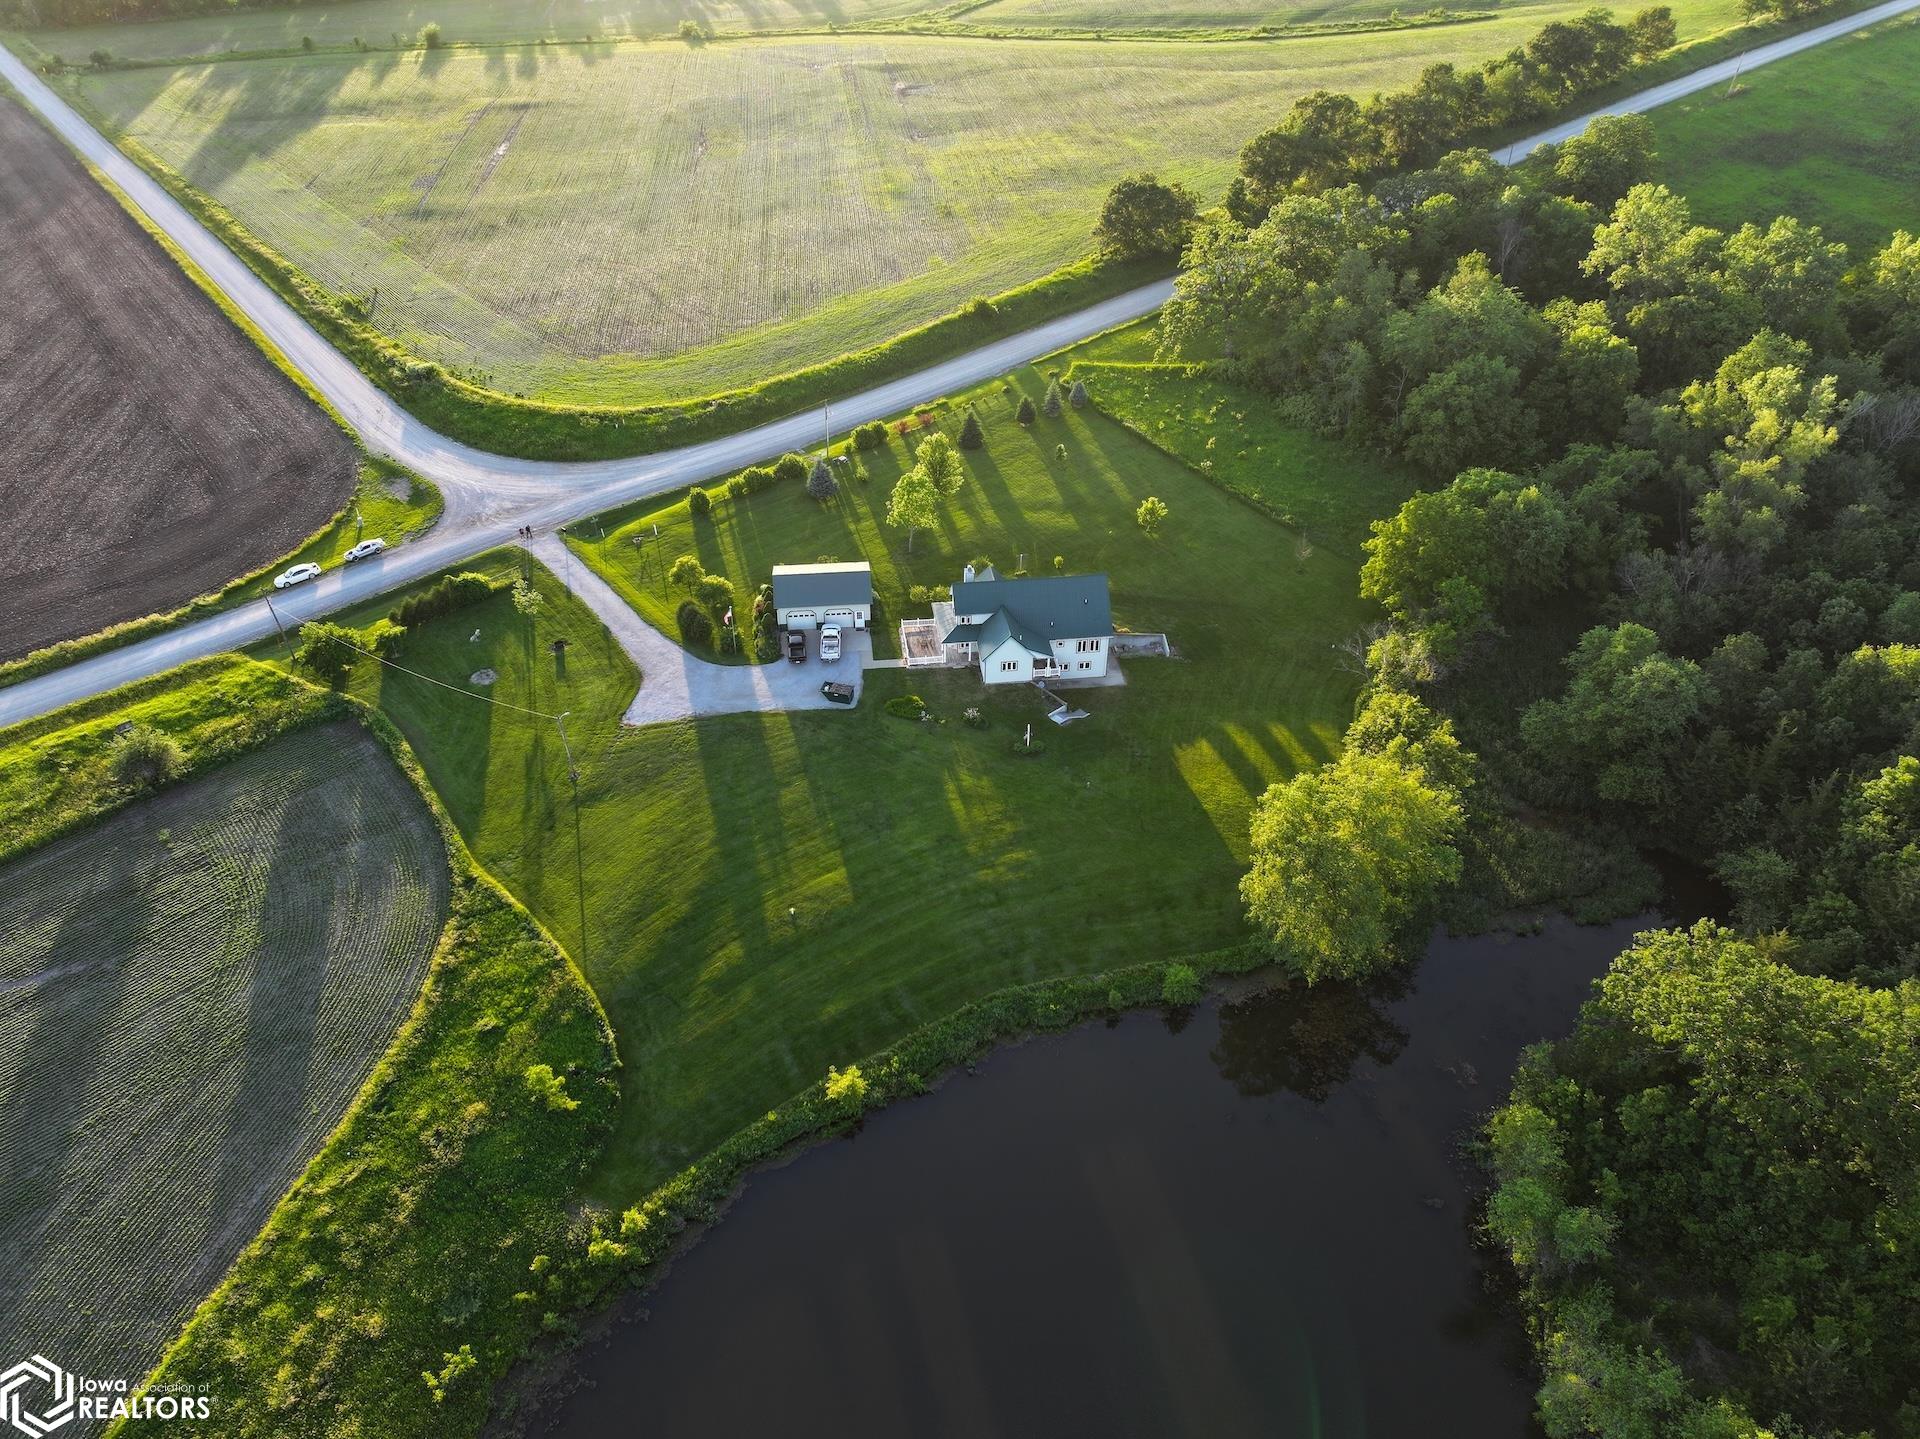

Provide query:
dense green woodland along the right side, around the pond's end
left=1164, top=86, right=1920, bottom=1439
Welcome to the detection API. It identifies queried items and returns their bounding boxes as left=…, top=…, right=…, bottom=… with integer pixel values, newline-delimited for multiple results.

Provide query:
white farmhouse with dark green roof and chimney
left=943, top=565, right=1114, bottom=684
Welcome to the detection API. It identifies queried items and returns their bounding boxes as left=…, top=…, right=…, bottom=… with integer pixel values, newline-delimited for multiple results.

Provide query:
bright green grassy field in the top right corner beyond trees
left=1653, top=15, right=1920, bottom=245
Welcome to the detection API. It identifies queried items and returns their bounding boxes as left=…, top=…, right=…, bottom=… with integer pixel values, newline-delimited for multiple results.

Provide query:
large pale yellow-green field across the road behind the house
left=73, top=2, right=1728, bottom=403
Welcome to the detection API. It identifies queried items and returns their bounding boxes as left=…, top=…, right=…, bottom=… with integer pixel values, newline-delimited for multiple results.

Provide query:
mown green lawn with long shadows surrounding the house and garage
left=274, top=365, right=1405, bottom=1203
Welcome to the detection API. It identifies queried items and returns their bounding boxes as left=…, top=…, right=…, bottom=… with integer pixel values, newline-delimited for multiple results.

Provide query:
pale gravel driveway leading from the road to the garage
left=522, top=534, right=874, bottom=726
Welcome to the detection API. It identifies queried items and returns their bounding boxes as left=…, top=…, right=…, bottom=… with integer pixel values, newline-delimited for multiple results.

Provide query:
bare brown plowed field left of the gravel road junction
left=0, top=96, right=357, bottom=659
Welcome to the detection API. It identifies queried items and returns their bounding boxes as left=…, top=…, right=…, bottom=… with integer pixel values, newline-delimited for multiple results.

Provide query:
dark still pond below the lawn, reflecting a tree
left=534, top=922, right=1642, bottom=1439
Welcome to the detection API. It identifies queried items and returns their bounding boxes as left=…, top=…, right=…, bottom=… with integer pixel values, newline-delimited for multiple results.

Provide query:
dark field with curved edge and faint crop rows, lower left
left=0, top=724, right=447, bottom=1379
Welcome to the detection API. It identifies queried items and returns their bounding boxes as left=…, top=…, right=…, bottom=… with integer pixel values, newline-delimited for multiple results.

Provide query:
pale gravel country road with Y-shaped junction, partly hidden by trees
left=0, top=0, right=1920, bottom=726
